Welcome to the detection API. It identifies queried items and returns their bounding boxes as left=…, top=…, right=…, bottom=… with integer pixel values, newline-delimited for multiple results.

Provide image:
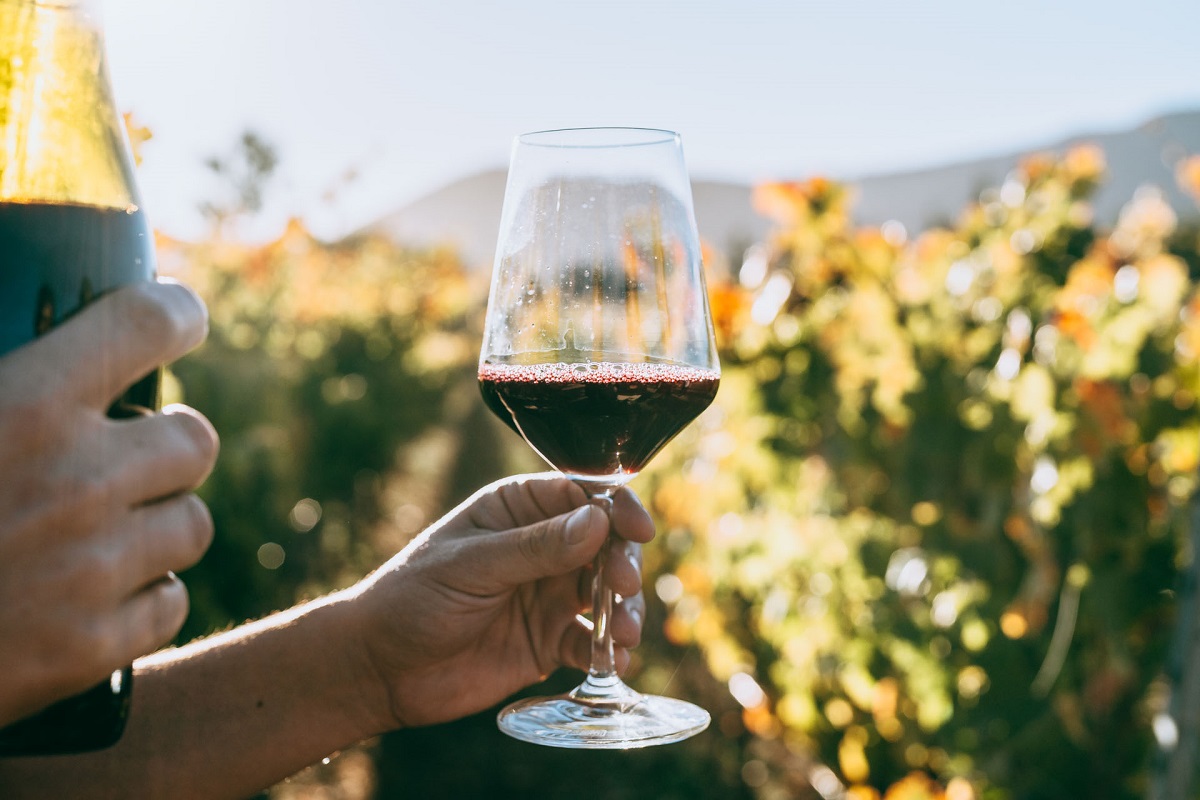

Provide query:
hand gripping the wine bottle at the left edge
left=0, top=282, right=217, bottom=726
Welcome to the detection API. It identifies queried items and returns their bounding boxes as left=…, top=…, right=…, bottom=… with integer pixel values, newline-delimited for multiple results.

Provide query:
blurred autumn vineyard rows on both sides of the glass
left=158, top=139, right=1200, bottom=800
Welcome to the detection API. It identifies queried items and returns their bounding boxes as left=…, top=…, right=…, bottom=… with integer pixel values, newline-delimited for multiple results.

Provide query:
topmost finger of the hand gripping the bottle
left=17, top=282, right=208, bottom=409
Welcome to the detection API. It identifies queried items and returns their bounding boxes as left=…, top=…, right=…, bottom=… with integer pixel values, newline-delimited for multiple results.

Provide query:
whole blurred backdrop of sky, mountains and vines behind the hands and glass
left=104, top=0, right=1200, bottom=800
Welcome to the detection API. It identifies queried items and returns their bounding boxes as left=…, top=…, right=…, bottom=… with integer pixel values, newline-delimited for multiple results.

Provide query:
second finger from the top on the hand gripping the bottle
left=108, top=405, right=220, bottom=505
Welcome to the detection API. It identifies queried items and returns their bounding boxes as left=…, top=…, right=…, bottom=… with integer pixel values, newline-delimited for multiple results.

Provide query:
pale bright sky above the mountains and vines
left=102, top=0, right=1200, bottom=237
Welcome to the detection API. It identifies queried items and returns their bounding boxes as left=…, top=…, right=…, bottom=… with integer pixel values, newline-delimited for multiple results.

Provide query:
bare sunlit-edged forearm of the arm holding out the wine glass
left=0, top=587, right=385, bottom=798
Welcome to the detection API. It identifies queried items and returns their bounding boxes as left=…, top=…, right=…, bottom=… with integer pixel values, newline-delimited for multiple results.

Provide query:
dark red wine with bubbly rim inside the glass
left=479, top=362, right=720, bottom=479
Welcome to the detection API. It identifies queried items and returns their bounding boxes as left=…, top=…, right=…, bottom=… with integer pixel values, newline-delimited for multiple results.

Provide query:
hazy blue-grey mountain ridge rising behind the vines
left=367, top=110, right=1200, bottom=267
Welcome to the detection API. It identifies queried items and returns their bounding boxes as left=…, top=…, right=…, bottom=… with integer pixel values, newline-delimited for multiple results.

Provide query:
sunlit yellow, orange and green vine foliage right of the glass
left=650, top=144, right=1200, bottom=800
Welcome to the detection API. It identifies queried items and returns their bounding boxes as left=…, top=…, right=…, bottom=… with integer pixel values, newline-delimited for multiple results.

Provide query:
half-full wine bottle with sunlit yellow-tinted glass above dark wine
left=0, top=0, right=160, bottom=756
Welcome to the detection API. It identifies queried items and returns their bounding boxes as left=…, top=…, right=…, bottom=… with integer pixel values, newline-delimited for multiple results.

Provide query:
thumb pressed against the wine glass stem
left=479, top=505, right=610, bottom=588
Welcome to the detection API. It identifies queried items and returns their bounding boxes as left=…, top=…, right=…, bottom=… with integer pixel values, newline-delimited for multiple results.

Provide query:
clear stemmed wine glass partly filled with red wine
left=479, top=128, right=720, bottom=748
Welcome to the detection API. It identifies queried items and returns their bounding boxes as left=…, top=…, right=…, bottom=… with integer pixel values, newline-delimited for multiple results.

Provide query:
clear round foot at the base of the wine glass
left=496, top=686, right=710, bottom=750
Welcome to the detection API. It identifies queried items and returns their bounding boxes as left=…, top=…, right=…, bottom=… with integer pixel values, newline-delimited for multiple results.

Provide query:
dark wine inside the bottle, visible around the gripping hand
left=0, top=203, right=158, bottom=756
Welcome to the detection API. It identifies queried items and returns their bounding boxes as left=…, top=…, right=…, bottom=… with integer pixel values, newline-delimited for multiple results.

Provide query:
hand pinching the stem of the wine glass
left=353, top=474, right=654, bottom=732
